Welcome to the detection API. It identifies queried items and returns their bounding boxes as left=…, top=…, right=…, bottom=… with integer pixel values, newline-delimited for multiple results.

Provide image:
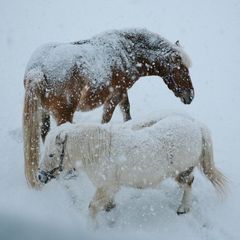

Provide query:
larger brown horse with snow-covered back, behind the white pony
left=23, top=29, right=194, bottom=187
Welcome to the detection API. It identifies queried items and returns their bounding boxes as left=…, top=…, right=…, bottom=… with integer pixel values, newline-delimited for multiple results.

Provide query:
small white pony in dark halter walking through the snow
left=38, top=115, right=226, bottom=218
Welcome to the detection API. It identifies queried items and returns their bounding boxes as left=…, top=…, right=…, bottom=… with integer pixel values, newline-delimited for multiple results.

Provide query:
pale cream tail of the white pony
left=200, top=124, right=228, bottom=196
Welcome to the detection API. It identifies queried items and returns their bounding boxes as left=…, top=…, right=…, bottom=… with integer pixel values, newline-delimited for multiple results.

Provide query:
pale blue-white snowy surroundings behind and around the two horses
left=0, top=0, right=240, bottom=240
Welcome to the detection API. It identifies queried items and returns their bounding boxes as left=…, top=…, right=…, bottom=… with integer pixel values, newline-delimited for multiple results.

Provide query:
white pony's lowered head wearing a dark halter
left=38, top=132, right=67, bottom=183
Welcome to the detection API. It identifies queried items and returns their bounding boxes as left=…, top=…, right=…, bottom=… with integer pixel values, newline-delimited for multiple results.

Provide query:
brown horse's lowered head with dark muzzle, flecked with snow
left=162, top=55, right=194, bottom=104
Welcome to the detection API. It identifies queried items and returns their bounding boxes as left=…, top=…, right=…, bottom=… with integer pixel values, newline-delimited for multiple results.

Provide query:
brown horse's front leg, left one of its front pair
left=102, top=94, right=121, bottom=123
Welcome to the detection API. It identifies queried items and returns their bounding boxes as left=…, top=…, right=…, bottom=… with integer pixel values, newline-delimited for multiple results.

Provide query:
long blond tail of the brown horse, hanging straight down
left=23, top=72, right=45, bottom=188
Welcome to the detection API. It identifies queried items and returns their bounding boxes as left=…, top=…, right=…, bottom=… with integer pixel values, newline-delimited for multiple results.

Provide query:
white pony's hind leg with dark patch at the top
left=176, top=167, right=194, bottom=215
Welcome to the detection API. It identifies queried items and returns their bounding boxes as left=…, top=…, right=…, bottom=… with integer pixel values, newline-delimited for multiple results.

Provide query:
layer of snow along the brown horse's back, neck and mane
left=26, top=29, right=190, bottom=87
